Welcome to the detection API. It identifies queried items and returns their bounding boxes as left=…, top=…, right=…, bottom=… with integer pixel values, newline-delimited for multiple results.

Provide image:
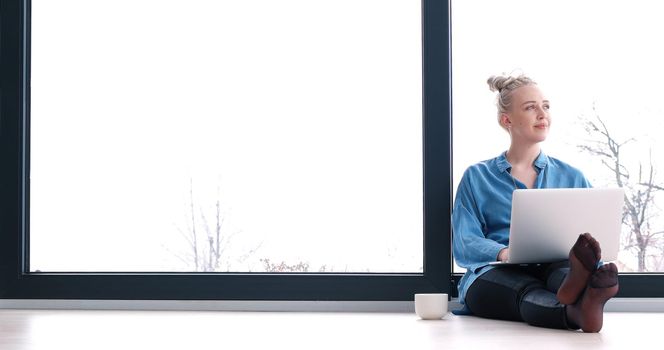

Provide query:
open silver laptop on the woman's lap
left=497, top=188, right=624, bottom=264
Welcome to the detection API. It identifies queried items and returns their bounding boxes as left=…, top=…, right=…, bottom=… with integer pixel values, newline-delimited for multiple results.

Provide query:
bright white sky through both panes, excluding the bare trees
left=31, top=0, right=664, bottom=271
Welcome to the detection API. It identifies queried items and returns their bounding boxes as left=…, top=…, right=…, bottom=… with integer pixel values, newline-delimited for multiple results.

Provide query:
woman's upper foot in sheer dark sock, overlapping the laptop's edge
left=556, top=233, right=602, bottom=305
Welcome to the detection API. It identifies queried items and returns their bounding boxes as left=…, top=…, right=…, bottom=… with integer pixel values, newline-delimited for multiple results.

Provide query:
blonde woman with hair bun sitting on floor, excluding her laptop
left=452, top=75, right=618, bottom=332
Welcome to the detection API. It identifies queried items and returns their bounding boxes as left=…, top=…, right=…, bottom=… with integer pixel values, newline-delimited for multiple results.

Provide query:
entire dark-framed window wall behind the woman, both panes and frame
left=0, top=0, right=664, bottom=300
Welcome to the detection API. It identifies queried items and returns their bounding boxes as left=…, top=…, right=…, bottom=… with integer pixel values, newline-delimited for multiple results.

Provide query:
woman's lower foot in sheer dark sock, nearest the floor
left=567, top=263, right=618, bottom=333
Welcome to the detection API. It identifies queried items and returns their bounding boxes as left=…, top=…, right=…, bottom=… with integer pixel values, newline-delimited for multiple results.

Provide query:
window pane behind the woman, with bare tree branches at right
left=452, top=0, right=664, bottom=272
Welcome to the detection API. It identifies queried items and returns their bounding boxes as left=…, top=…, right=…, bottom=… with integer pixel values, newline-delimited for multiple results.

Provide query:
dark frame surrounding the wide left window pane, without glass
left=0, top=0, right=452, bottom=301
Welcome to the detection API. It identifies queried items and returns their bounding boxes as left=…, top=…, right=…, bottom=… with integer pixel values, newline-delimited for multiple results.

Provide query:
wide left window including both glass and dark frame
left=0, top=0, right=450, bottom=300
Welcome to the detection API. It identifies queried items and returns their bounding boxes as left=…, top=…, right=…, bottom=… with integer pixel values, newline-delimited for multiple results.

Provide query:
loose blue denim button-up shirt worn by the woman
left=452, top=152, right=591, bottom=304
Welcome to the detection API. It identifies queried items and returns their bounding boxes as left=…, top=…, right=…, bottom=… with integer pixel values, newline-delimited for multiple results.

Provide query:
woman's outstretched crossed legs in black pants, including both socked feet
left=466, top=233, right=618, bottom=332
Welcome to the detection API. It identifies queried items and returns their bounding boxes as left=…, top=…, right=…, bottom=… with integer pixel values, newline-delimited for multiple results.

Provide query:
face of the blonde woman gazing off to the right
left=501, top=85, right=551, bottom=143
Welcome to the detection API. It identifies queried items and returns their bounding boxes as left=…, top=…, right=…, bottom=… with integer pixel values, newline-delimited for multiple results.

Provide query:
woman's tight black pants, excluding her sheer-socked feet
left=466, top=262, right=578, bottom=329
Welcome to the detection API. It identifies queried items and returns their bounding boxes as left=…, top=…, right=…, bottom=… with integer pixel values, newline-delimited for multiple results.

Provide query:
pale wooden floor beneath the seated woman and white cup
left=0, top=310, right=664, bottom=350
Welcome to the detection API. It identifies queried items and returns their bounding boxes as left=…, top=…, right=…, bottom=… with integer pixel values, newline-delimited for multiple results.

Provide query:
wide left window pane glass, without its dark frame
left=30, top=0, right=423, bottom=272
